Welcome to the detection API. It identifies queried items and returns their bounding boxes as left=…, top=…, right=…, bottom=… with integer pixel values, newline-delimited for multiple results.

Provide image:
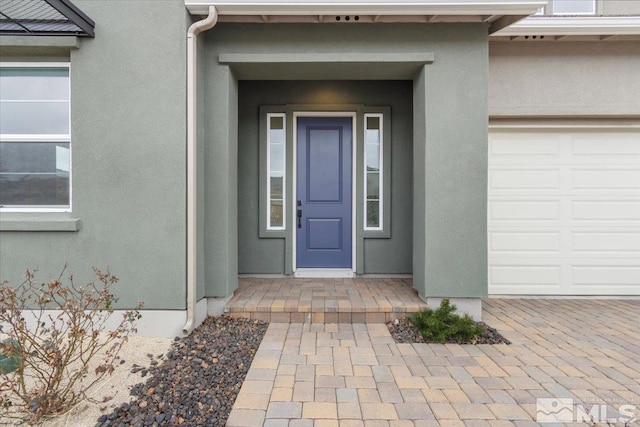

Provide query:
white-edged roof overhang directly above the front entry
left=185, top=0, right=547, bottom=31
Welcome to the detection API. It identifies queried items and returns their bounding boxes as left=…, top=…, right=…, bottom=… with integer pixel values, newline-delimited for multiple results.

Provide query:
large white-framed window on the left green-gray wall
left=0, top=63, right=71, bottom=211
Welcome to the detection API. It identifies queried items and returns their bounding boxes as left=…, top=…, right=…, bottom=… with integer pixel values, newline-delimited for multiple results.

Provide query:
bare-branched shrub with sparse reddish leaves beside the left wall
left=0, top=265, right=142, bottom=423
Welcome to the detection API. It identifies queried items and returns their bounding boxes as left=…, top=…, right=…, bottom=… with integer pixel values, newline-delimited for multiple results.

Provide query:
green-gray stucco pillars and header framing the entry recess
left=200, top=24, right=488, bottom=297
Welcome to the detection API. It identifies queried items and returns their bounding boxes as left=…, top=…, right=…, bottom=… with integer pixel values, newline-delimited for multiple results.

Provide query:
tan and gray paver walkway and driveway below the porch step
left=227, top=299, right=640, bottom=427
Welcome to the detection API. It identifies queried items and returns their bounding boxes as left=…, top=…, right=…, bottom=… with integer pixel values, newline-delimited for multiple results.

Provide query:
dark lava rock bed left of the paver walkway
left=96, top=316, right=267, bottom=427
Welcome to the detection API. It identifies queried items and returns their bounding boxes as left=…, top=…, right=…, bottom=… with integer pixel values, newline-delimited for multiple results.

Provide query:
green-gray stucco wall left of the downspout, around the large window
left=0, top=0, right=191, bottom=310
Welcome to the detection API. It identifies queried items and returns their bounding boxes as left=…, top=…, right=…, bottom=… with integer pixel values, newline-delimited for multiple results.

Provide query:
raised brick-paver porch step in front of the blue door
left=224, top=277, right=427, bottom=323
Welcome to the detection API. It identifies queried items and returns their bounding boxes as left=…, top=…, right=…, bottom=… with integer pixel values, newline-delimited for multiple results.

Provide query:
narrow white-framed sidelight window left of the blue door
left=267, top=113, right=287, bottom=230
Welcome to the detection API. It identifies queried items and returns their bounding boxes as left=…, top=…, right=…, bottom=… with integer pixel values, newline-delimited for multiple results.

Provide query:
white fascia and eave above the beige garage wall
left=492, top=16, right=640, bottom=37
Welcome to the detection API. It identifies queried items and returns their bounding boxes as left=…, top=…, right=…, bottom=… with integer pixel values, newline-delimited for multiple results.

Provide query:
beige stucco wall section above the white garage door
left=489, top=41, right=640, bottom=117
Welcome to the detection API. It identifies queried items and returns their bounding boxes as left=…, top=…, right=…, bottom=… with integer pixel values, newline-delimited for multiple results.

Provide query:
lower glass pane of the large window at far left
left=0, top=142, right=70, bottom=206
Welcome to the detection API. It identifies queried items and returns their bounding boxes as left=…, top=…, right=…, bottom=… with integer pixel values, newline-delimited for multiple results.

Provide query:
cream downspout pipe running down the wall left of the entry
left=182, top=6, right=218, bottom=334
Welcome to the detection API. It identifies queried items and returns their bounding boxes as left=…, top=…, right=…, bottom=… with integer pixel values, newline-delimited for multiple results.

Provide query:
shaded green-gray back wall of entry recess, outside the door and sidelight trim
left=238, top=80, right=413, bottom=274
